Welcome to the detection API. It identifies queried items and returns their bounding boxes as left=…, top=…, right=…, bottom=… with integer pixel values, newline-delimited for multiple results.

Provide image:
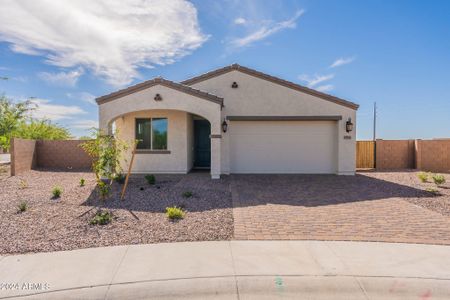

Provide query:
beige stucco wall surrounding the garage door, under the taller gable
left=192, top=71, right=356, bottom=174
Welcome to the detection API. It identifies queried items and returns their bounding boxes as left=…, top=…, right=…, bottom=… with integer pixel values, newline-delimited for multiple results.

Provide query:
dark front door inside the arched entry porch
left=194, top=120, right=211, bottom=168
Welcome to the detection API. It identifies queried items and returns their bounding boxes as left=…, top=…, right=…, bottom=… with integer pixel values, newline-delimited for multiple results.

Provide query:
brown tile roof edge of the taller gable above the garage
left=181, top=64, right=359, bottom=110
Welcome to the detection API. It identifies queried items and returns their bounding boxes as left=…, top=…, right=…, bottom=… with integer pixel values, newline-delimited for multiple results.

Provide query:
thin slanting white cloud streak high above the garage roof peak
left=230, top=10, right=304, bottom=48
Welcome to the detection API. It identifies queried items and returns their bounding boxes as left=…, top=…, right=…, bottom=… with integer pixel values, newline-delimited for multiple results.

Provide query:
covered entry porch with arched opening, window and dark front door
left=97, top=78, right=223, bottom=179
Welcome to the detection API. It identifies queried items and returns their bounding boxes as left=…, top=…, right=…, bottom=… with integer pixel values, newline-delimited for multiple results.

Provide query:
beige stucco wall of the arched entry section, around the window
left=99, top=85, right=222, bottom=178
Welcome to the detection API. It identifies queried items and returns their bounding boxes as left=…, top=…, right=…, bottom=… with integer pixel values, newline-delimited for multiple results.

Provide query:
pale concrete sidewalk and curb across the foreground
left=0, top=241, right=450, bottom=299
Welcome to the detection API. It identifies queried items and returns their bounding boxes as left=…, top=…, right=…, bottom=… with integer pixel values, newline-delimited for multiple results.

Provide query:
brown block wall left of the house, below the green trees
left=10, top=138, right=92, bottom=176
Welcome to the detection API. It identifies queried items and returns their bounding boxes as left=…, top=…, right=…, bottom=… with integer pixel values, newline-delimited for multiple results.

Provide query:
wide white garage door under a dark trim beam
left=229, top=121, right=337, bottom=173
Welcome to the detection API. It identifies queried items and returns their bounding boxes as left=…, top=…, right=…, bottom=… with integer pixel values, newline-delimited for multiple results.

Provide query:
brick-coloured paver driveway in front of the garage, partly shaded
left=231, top=172, right=450, bottom=244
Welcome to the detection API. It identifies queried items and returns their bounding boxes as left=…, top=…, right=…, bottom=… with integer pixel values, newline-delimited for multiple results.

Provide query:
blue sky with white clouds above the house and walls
left=0, top=0, right=450, bottom=139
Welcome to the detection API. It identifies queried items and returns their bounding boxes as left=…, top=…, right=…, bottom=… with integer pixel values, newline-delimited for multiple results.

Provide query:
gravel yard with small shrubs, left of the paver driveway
left=0, top=170, right=233, bottom=255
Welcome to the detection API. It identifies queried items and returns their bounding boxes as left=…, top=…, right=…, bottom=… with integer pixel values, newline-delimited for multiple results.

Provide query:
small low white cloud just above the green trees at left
left=31, top=98, right=86, bottom=121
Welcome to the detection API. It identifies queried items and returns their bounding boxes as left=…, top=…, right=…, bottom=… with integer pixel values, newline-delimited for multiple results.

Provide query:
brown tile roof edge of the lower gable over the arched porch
left=95, top=77, right=223, bottom=106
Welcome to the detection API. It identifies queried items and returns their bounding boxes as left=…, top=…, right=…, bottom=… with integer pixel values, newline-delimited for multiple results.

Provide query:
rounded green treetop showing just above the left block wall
left=13, top=119, right=71, bottom=140
